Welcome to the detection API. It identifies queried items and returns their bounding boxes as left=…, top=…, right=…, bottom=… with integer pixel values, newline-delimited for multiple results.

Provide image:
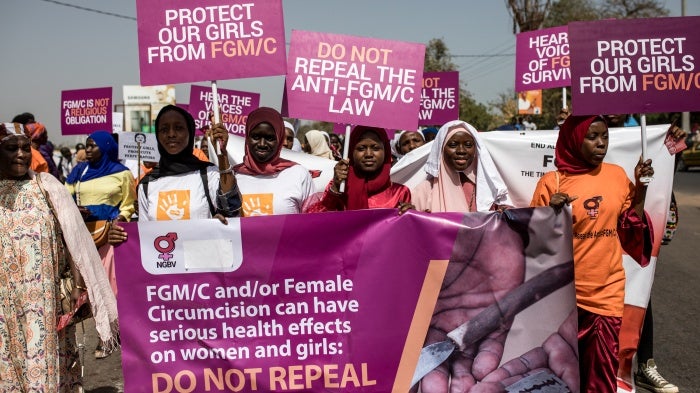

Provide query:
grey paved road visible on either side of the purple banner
left=78, top=171, right=700, bottom=393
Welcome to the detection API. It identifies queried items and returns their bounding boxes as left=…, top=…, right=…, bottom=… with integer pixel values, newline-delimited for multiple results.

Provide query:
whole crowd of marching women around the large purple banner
left=0, top=105, right=686, bottom=392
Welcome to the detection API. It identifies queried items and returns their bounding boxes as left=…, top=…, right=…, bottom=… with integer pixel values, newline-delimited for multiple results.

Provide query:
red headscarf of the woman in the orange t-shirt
left=554, top=116, right=605, bottom=174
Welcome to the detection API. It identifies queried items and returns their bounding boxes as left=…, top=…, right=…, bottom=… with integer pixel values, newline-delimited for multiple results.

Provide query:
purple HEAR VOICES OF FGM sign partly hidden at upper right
left=515, top=26, right=571, bottom=92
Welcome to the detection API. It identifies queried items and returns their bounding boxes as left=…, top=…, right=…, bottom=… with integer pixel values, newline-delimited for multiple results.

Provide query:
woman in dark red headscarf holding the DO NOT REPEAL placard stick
left=307, top=126, right=414, bottom=213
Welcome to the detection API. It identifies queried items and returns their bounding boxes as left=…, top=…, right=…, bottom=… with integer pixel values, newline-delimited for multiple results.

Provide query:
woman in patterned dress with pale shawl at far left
left=0, top=123, right=117, bottom=393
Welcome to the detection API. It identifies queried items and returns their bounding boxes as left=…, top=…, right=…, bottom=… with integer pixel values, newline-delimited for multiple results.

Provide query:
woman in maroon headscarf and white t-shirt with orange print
left=233, top=107, right=313, bottom=217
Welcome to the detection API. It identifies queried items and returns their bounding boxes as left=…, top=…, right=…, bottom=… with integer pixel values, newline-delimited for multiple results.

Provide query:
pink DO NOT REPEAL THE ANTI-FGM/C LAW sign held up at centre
left=286, top=30, right=425, bottom=130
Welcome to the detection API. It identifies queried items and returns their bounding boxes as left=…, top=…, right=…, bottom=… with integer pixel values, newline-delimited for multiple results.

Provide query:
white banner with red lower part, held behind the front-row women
left=391, top=124, right=674, bottom=392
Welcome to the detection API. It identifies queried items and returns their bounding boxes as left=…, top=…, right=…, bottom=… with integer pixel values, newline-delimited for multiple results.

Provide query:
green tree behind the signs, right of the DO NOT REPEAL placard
left=423, top=38, right=493, bottom=130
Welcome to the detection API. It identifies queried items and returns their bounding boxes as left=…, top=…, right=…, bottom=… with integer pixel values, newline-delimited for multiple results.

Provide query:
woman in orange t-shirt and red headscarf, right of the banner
left=531, top=116, right=654, bottom=392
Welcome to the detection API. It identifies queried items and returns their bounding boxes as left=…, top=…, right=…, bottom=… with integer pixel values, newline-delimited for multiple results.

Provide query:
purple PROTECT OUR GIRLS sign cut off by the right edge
left=569, top=16, right=700, bottom=115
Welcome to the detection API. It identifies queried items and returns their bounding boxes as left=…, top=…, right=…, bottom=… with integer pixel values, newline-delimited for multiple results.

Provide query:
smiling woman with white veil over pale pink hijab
left=411, top=120, right=512, bottom=212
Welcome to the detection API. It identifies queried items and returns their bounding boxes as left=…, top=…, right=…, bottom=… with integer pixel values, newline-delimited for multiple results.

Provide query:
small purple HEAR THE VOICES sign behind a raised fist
left=189, top=85, right=260, bottom=136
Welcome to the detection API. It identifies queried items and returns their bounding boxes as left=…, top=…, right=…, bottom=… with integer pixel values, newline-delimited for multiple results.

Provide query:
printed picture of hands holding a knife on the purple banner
left=412, top=209, right=578, bottom=393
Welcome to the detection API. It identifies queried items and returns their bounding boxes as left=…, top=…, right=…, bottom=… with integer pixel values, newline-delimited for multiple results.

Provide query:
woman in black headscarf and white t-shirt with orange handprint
left=109, top=105, right=241, bottom=244
